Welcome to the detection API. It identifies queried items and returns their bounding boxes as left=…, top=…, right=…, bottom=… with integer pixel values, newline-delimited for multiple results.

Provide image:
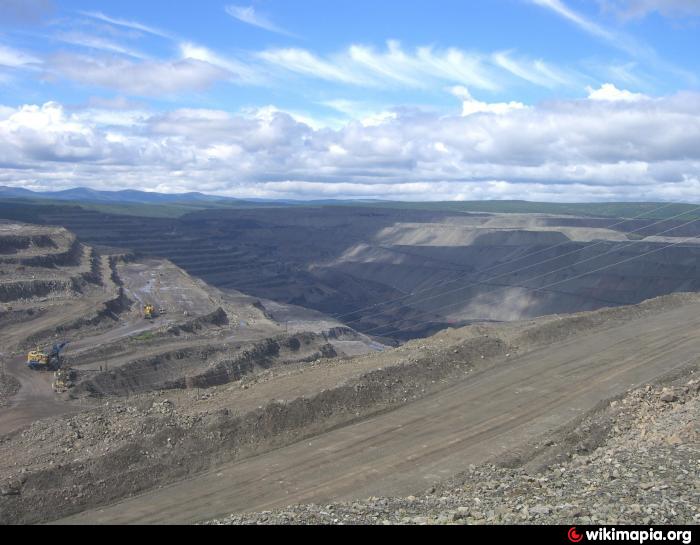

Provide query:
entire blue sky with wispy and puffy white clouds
left=0, top=0, right=700, bottom=202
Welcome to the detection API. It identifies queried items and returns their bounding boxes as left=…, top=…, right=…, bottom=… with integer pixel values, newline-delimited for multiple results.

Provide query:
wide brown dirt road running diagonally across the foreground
left=60, top=302, right=700, bottom=524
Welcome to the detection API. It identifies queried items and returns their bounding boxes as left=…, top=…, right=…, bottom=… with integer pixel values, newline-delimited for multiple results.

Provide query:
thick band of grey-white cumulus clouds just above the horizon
left=0, top=90, right=700, bottom=201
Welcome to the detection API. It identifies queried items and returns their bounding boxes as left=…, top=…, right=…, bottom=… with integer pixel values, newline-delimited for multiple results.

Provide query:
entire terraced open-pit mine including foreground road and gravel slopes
left=0, top=200, right=700, bottom=524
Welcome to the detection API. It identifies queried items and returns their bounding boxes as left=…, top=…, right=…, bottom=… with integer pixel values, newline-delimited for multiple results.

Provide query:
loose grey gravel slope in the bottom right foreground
left=209, top=377, right=700, bottom=525
